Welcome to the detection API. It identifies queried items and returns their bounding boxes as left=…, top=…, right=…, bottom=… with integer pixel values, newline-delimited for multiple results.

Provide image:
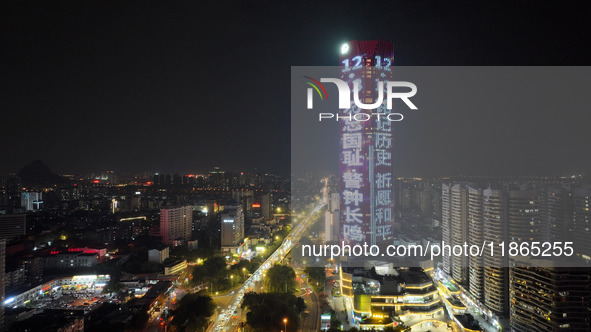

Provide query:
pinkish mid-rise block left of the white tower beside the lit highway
left=160, top=206, right=193, bottom=245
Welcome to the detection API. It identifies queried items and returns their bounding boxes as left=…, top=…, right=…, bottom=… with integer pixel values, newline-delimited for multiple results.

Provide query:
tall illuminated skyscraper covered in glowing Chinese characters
left=339, top=40, right=394, bottom=245
